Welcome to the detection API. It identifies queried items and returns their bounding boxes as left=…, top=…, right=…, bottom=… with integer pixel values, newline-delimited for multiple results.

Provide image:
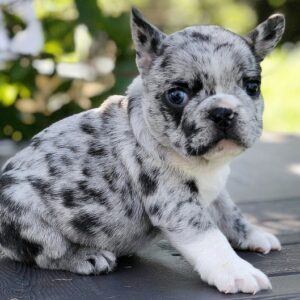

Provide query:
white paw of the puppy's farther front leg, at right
left=239, top=228, right=281, bottom=254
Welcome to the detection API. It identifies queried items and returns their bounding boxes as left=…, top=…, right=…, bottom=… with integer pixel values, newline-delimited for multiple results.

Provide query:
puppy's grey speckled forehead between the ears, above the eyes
left=153, top=26, right=260, bottom=85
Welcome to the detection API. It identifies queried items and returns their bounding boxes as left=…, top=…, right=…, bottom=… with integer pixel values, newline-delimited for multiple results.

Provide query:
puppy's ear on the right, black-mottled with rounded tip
left=246, top=14, right=285, bottom=61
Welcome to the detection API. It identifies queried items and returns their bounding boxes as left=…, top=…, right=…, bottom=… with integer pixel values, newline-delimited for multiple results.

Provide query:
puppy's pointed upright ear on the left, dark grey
left=131, top=8, right=165, bottom=74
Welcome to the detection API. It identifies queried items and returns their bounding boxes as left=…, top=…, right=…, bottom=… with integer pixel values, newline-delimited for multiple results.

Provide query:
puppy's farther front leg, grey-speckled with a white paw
left=209, top=192, right=281, bottom=254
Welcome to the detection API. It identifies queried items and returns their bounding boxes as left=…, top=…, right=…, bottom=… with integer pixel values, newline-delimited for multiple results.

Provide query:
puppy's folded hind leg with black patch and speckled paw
left=0, top=213, right=116, bottom=274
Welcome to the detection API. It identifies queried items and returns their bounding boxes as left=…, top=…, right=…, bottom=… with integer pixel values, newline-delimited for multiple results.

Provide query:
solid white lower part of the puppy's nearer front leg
left=173, top=229, right=271, bottom=294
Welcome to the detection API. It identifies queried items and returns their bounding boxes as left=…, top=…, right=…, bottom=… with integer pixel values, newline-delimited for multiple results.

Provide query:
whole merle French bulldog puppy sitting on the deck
left=0, top=9, right=285, bottom=293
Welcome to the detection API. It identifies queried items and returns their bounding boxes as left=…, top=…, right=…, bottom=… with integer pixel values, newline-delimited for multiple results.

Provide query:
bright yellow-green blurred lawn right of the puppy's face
left=262, top=45, right=300, bottom=132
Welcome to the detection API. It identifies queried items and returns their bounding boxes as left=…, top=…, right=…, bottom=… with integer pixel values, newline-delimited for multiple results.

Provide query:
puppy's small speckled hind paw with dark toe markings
left=72, top=250, right=116, bottom=275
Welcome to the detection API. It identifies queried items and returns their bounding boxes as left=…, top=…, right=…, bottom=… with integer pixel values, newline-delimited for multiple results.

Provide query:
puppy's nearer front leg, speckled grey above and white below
left=144, top=198, right=271, bottom=293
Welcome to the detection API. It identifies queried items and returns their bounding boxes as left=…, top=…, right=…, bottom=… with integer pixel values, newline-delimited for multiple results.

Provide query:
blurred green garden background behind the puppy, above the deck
left=0, top=0, right=300, bottom=143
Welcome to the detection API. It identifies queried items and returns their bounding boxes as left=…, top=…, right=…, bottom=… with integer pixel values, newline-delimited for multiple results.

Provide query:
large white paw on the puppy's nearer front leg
left=201, top=254, right=272, bottom=294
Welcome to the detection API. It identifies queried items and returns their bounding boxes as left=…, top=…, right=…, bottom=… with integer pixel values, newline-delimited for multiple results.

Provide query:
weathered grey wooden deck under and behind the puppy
left=0, top=134, right=300, bottom=300
